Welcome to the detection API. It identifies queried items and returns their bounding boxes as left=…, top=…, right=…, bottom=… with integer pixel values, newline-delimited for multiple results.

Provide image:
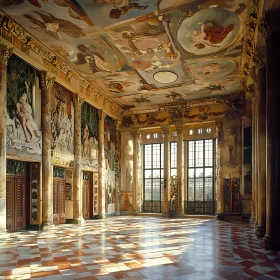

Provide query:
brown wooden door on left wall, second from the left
left=53, top=179, right=66, bottom=225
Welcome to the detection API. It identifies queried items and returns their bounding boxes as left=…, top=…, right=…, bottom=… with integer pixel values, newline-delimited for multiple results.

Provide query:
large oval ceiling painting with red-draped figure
left=177, top=7, right=240, bottom=55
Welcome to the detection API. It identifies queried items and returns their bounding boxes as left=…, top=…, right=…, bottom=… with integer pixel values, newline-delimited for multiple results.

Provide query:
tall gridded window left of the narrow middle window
left=143, top=144, right=164, bottom=213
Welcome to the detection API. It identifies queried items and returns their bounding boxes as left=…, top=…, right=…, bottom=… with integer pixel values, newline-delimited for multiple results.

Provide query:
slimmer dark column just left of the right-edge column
left=256, top=67, right=266, bottom=237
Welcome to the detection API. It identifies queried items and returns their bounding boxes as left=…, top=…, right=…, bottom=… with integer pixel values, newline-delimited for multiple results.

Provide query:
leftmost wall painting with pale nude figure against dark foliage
left=7, top=56, right=42, bottom=155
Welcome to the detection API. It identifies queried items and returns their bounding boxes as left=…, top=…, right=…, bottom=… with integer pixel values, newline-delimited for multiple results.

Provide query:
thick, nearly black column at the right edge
left=264, top=10, right=280, bottom=250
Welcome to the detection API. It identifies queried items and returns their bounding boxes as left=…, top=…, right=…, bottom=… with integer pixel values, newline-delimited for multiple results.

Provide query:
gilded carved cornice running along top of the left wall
left=0, top=11, right=123, bottom=115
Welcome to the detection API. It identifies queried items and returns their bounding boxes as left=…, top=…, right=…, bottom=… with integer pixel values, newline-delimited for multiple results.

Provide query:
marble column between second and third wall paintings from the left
left=72, top=94, right=85, bottom=224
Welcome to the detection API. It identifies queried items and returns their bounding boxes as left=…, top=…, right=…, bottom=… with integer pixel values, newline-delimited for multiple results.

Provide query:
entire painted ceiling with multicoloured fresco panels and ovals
left=0, top=0, right=248, bottom=113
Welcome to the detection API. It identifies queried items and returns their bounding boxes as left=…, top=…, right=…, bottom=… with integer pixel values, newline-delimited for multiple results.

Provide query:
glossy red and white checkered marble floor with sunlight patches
left=0, top=216, right=280, bottom=280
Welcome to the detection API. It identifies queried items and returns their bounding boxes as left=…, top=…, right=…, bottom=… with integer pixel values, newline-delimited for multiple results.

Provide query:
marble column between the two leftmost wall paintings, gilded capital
left=39, top=71, right=55, bottom=230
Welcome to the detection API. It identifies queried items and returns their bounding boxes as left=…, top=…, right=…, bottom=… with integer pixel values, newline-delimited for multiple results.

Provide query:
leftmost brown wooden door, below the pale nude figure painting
left=6, top=175, right=26, bottom=232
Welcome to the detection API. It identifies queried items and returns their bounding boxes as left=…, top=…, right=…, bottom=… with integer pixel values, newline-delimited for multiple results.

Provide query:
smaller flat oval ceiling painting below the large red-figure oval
left=189, top=58, right=236, bottom=80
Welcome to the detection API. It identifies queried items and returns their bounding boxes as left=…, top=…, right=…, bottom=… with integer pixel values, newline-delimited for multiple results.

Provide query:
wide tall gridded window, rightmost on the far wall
left=185, top=139, right=215, bottom=215
